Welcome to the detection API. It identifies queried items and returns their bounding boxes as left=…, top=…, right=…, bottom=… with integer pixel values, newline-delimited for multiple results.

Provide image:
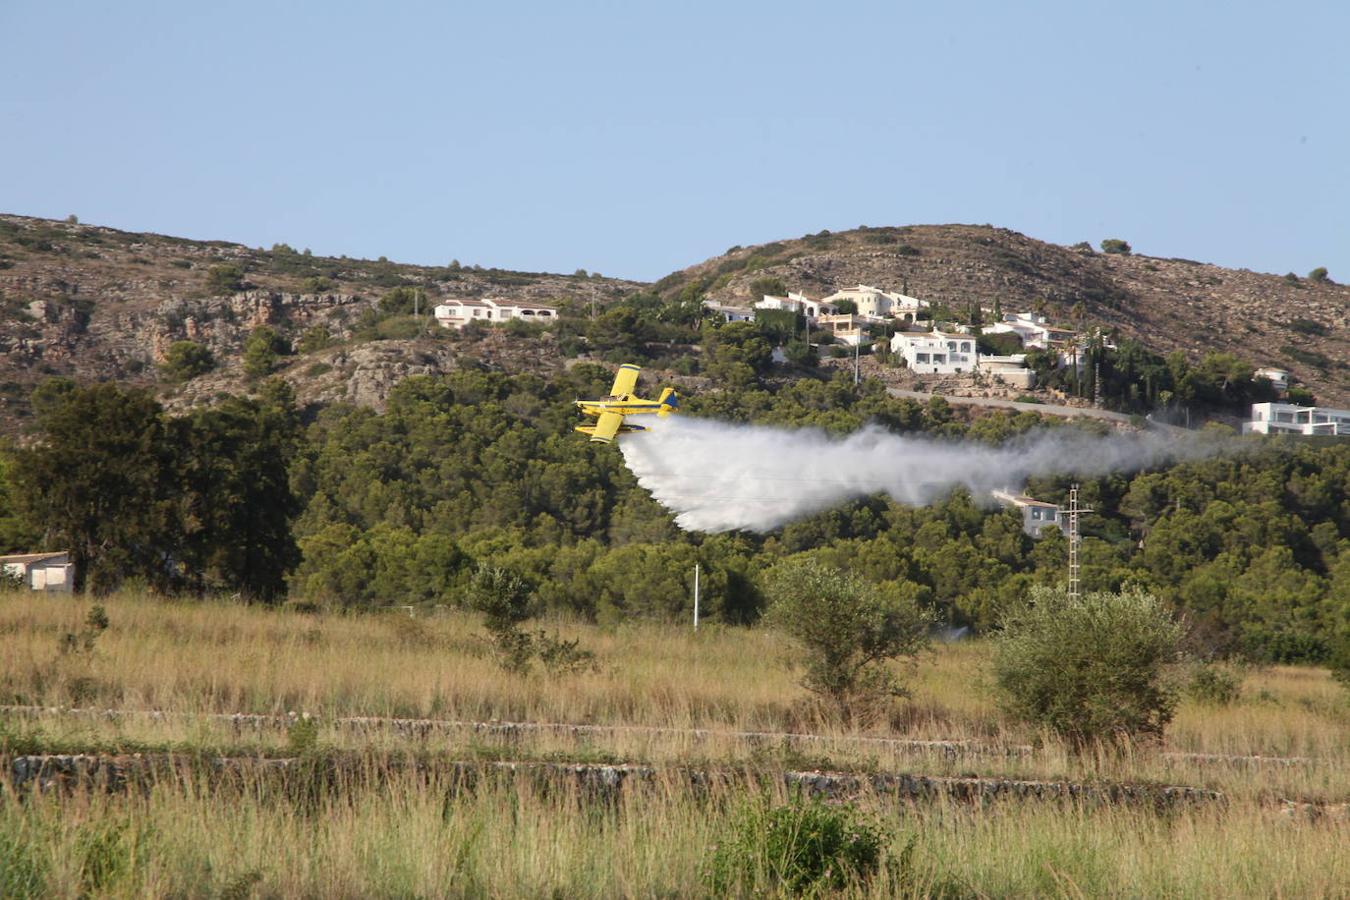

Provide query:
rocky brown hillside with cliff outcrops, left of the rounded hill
left=0, top=216, right=644, bottom=430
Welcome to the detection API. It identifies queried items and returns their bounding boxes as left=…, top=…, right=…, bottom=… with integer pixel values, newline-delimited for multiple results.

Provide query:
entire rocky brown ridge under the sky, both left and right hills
left=0, top=216, right=1350, bottom=432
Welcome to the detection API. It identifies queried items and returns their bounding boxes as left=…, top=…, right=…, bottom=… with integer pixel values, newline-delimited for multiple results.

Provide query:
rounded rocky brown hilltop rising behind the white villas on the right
left=656, top=225, right=1350, bottom=406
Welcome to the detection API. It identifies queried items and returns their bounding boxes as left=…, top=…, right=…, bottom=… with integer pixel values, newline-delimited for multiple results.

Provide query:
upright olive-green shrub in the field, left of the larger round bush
left=767, top=560, right=932, bottom=719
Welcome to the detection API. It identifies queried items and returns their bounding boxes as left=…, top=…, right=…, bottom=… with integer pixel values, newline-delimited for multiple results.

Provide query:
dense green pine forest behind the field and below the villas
left=0, top=353, right=1350, bottom=669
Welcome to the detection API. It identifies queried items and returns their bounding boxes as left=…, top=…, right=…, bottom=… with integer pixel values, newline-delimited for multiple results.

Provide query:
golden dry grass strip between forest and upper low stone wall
left=0, top=594, right=1350, bottom=756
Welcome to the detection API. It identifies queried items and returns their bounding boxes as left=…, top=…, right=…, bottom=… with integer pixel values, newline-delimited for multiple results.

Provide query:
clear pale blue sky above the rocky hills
left=0, top=0, right=1350, bottom=281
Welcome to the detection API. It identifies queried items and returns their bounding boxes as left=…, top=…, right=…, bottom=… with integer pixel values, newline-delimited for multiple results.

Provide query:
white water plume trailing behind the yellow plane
left=620, top=417, right=1219, bottom=533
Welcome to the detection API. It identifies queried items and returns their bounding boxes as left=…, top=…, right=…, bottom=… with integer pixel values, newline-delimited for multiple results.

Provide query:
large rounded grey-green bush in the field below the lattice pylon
left=994, top=588, right=1183, bottom=748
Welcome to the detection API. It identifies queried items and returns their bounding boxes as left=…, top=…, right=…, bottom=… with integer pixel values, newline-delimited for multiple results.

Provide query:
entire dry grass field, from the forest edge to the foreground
left=0, top=594, right=1350, bottom=897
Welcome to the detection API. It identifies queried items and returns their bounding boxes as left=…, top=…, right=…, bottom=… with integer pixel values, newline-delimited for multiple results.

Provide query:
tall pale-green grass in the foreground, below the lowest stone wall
left=0, top=775, right=1350, bottom=897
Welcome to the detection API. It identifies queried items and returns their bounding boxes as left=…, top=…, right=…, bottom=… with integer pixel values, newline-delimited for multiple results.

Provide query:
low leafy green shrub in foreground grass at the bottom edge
left=705, top=796, right=913, bottom=897
